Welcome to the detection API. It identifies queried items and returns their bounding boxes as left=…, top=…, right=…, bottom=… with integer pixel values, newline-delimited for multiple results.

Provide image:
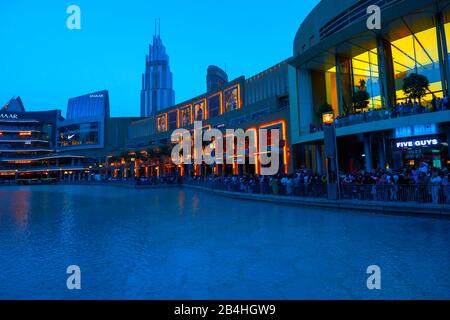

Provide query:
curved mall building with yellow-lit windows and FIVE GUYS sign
left=289, top=0, right=450, bottom=172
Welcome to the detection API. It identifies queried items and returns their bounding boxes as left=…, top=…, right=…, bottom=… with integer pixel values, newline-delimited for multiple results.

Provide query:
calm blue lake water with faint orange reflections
left=0, top=186, right=450, bottom=299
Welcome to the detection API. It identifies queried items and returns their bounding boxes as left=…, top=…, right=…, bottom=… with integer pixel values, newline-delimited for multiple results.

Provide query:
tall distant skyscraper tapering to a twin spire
left=141, top=20, right=175, bottom=117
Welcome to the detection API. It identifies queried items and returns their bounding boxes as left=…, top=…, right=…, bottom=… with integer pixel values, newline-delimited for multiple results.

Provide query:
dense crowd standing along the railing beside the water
left=184, top=162, right=450, bottom=204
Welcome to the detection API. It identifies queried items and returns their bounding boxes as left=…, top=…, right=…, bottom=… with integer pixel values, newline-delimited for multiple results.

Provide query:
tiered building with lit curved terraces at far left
left=0, top=98, right=88, bottom=183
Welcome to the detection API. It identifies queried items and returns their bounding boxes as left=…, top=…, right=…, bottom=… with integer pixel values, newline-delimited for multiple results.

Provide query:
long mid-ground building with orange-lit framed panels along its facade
left=123, top=61, right=291, bottom=176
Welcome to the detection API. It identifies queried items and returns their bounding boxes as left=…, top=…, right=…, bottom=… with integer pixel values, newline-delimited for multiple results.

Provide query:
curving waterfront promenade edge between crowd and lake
left=0, top=178, right=450, bottom=218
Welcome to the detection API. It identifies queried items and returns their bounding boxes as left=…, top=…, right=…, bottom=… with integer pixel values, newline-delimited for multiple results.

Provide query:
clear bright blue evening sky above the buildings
left=0, top=0, right=318, bottom=116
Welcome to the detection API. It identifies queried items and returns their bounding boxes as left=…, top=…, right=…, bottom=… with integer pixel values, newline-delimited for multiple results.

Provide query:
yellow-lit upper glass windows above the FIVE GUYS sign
left=313, top=22, right=450, bottom=116
